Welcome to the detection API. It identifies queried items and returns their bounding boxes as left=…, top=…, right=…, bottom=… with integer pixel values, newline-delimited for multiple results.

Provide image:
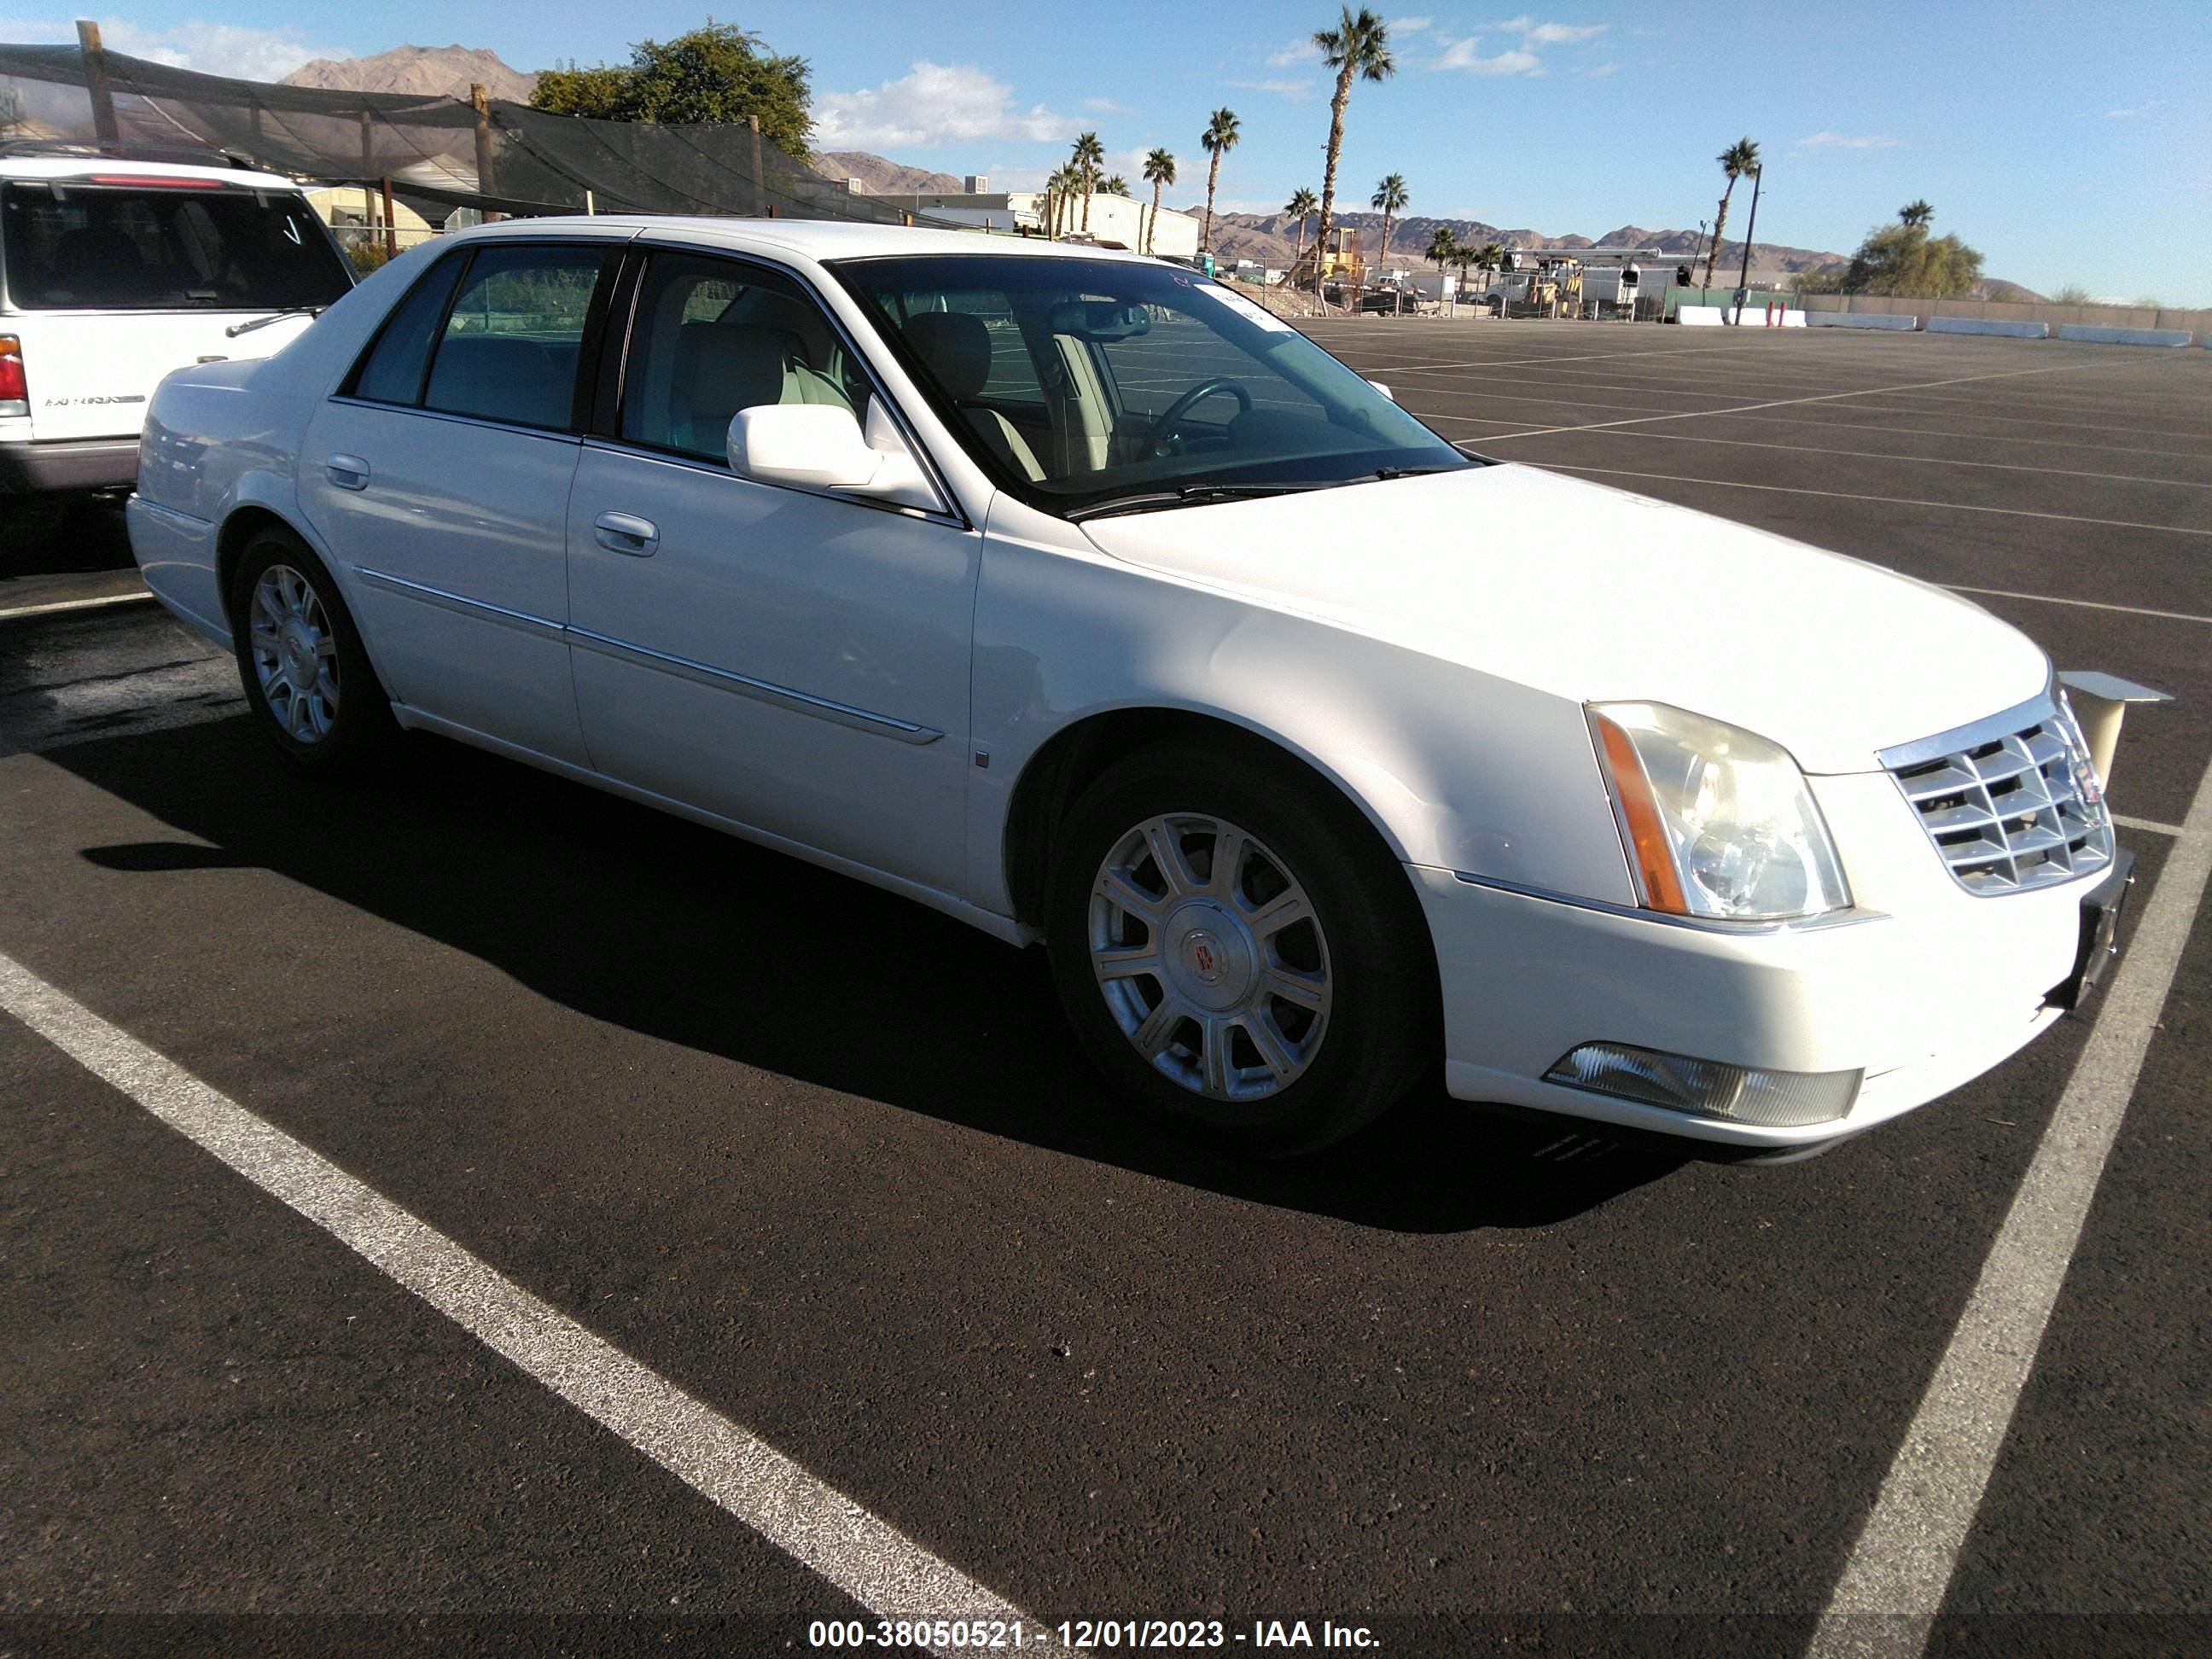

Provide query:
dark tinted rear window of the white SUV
left=0, top=182, right=354, bottom=311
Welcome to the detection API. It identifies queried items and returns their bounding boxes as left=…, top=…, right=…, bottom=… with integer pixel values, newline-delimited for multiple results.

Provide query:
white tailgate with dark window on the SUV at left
left=0, top=172, right=352, bottom=440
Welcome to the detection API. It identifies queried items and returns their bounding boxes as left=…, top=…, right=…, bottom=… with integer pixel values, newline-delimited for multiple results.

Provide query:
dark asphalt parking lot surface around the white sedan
left=0, top=318, right=2212, bottom=1655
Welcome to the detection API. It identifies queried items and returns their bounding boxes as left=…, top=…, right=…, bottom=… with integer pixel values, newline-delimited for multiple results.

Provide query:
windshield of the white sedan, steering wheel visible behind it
left=832, top=254, right=1477, bottom=513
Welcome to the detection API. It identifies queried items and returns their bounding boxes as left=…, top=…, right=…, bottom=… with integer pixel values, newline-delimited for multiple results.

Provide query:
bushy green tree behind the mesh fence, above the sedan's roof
left=531, top=22, right=814, bottom=160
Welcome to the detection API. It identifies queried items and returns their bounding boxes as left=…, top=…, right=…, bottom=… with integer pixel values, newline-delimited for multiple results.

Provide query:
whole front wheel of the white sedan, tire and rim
left=1046, top=741, right=1438, bottom=1157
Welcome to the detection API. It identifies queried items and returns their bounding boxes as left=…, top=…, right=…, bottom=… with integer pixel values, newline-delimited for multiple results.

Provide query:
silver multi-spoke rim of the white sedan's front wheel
left=1088, top=812, right=1331, bottom=1102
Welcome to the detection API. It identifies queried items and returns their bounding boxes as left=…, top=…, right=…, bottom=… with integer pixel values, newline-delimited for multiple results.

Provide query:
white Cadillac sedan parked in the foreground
left=131, top=219, right=2128, bottom=1155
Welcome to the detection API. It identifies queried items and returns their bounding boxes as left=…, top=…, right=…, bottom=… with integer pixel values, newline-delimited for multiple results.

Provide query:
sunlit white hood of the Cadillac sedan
left=1081, top=463, right=2051, bottom=772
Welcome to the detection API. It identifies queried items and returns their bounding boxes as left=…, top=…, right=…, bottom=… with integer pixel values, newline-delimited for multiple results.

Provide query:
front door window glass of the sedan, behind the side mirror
left=621, top=252, right=871, bottom=460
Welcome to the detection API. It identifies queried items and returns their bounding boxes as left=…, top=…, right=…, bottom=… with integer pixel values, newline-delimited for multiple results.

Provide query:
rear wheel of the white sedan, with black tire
left=230, top=528, right=399, bottom=777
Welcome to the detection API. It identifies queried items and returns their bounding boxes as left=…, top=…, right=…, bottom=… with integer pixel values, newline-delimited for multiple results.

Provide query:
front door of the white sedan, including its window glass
left=568, top=250, right=980, bottom=892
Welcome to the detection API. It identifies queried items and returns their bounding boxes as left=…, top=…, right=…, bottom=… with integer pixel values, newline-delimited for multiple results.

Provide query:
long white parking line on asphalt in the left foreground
left=0, top=953, right=1044, bottom=1652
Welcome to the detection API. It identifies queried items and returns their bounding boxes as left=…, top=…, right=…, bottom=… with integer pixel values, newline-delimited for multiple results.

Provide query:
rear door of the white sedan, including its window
left=299, top=239, right=621, bottom=765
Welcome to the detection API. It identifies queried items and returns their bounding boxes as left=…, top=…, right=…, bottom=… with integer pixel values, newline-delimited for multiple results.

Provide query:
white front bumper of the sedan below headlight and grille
left=1407, top=778, right=2097, bottom=1148
